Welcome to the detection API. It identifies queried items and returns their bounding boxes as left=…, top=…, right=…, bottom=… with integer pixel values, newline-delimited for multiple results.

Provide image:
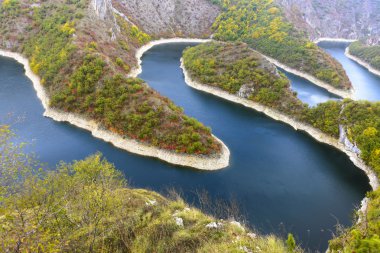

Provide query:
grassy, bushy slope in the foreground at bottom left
left=0, top=126, right=300, bottom=253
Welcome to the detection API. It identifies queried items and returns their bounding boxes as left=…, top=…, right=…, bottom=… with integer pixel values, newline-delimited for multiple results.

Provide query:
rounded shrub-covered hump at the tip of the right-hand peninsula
left=183, top=42, right=307, bottom=117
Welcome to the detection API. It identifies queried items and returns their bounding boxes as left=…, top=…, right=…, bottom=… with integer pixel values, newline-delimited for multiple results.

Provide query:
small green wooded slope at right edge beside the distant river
left=349, top=41, right=380, bottom=70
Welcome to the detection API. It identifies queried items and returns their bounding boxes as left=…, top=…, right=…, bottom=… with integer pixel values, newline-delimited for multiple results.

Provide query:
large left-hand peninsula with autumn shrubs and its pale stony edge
left=2, top=1, right=230, bottom=170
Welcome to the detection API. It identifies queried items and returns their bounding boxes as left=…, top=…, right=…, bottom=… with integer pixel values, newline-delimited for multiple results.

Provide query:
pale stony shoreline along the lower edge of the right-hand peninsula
left=181, top=59, right=379, bottom=190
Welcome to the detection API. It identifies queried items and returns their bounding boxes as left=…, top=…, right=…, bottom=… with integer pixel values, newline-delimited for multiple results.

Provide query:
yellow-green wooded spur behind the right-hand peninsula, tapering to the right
left=209, top=0, right=351, bottom=89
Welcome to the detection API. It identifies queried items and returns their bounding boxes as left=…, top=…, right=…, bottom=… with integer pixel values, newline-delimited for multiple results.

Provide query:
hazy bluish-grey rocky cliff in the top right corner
left=276, top=0, right=380, bottom=45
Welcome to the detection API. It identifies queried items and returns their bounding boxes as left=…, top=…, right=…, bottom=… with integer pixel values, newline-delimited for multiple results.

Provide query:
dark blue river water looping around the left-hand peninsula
left=0, top=44, right=370, bottom=251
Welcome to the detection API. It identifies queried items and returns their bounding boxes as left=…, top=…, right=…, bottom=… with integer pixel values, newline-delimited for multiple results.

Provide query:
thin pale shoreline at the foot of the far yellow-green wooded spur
left=253, top=50, right=353, bottom=99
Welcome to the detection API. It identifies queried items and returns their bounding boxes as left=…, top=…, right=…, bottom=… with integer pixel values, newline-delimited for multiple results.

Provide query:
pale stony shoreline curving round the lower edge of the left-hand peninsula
left=0, top=50, right=230, bottom=170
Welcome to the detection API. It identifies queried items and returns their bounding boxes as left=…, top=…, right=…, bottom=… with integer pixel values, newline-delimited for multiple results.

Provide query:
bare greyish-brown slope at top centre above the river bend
left=113, top=0, right=220, bottom=37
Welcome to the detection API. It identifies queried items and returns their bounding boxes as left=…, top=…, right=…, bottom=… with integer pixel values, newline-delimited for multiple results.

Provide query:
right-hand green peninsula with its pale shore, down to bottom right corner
left=182, top=42, right=380, bottom=252
